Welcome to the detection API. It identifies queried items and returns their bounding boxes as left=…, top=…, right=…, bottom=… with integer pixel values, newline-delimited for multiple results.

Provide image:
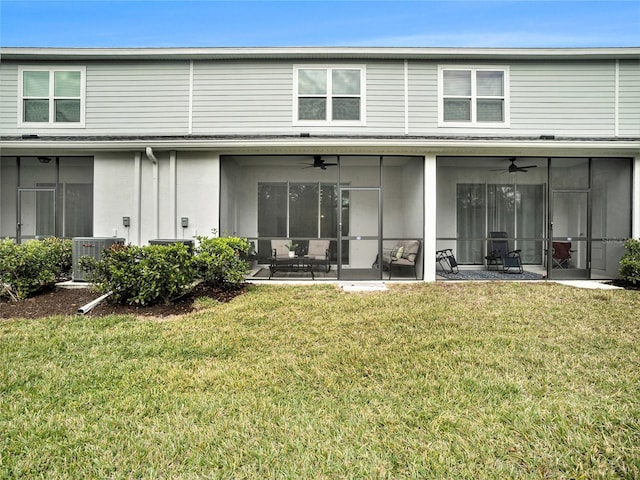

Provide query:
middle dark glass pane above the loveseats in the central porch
left=289, top=183, right=318, bottom=238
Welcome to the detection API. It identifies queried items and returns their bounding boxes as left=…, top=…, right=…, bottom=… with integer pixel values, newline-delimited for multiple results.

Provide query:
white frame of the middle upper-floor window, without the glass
left=292, top=65, right=367, bottom=126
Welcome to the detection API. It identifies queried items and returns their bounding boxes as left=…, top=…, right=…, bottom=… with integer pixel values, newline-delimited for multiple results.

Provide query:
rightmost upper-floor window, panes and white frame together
left=438, top=66, right=509, bottom=127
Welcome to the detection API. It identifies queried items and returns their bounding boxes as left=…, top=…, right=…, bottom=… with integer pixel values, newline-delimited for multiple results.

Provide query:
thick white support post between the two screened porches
left=422, top=154, right=437, bottom=282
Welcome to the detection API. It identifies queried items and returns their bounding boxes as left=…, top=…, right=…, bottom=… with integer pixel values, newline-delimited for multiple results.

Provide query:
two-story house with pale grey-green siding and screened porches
left=0, top=48, right=640, bottom=281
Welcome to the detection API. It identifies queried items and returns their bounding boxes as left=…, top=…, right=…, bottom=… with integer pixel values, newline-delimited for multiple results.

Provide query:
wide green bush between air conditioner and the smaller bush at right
left=80, top=243, right=196, bottom=306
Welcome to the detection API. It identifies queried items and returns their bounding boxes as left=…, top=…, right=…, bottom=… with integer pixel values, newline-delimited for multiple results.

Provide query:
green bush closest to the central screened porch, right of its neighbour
left=196, top=236, right=250, bottom=289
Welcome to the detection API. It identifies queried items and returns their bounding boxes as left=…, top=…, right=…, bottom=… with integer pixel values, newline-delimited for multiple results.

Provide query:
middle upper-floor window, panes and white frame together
left=294, top=66, right=365, bottom=125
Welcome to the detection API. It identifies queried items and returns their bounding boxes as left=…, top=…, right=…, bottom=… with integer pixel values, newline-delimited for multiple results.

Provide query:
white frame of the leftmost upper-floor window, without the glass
left=18, top=65, right=87, bottom=130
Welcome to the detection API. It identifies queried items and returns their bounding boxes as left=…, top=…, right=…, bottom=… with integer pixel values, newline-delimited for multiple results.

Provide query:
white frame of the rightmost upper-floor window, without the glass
left=438, top=65, right=511, bottom=128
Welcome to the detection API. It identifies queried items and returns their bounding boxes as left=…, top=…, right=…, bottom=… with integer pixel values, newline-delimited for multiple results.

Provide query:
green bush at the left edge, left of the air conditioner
left=0, top=237, right=71, bottom=301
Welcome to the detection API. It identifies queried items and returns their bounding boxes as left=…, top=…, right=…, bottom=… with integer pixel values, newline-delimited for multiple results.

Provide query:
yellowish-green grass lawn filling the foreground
left=0, top=283, right=640, bottom=479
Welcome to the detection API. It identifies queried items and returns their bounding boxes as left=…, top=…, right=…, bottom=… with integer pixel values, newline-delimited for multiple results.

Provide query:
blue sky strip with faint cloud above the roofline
left=0, top=0, right=640, bottom=47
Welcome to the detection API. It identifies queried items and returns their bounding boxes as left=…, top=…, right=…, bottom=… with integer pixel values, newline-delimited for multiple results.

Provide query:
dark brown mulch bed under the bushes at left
left=0, top=285, right=247, bottom=318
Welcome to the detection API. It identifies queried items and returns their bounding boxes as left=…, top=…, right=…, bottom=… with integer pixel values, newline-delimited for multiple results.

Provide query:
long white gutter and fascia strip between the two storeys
left=0, top=135, right=640, bottom=157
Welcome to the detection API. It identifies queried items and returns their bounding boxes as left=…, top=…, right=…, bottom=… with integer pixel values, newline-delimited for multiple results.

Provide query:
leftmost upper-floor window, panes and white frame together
left=18, top=67, right=85, bottom=127
